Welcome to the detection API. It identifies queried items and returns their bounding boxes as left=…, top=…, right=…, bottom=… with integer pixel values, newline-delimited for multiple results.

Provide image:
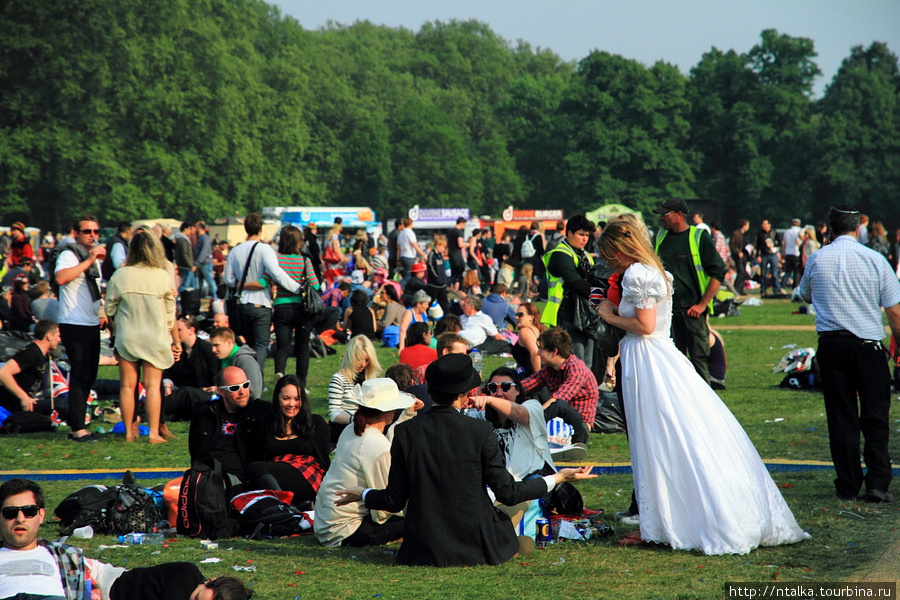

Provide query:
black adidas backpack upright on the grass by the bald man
left=176, top=458, right=237, bottom=540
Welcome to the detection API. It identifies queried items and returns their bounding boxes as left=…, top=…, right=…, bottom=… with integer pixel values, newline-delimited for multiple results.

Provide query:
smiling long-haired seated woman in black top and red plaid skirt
left=241, top=375, right=331, bottom=507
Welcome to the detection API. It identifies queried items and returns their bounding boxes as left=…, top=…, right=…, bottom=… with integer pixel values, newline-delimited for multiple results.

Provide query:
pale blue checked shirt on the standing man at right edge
left=799, top=235, right=900, bottom=340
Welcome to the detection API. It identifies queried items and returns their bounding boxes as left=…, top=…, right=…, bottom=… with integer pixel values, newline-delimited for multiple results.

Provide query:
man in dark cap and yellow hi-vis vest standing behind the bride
left=656, top=198, right=725, bottom=383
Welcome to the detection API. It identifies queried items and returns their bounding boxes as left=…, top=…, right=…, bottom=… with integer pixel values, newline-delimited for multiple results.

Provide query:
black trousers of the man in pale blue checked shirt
left=816, top=333, right=891, bottom=498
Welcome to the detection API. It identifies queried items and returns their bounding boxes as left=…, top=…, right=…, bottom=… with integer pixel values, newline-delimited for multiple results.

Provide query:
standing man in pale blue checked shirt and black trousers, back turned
left=798, top=205, right=900, bottom=502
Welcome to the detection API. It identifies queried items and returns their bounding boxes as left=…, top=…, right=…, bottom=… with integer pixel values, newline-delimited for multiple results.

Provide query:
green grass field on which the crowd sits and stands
left=0, top=301, right=900, bottom=600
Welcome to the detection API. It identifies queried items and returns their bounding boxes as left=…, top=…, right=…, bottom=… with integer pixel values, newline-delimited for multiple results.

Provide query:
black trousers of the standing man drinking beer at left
left=59, top=323, right=100, bottom=431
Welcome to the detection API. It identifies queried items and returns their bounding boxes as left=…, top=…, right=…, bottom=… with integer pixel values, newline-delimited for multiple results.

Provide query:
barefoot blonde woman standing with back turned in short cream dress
left=106, top=228, right=181, bottom=444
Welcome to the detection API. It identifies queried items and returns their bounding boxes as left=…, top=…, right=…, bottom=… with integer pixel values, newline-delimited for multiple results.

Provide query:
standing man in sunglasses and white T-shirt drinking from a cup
left=53, top=215, right=106, bottom=442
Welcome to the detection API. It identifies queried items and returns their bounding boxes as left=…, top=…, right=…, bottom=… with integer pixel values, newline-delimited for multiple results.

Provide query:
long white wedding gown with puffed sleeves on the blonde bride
left=619, top=263, right=809, bottom=554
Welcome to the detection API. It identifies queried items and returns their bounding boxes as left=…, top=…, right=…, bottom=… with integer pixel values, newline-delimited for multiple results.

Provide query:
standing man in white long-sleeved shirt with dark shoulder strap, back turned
left=222, top=213, right=300, bottom=373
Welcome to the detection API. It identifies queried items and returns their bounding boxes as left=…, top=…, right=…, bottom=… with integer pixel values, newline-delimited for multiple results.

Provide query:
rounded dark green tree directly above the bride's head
left=559, top=51, right=695, bottom=216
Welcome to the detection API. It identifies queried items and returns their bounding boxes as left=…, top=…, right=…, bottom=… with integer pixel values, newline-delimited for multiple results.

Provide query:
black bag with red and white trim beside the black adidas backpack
left=231, top=490, right=312, bottom=540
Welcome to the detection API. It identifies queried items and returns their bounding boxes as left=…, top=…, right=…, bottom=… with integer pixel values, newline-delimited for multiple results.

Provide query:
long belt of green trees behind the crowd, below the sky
left=0, top=0, right=900, bottom=230
